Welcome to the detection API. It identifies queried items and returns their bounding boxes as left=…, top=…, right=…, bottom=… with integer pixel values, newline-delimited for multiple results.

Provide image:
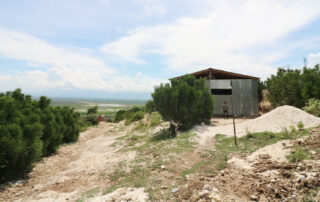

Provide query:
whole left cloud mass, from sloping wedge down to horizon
left=0, top=29, right=159, bottom=92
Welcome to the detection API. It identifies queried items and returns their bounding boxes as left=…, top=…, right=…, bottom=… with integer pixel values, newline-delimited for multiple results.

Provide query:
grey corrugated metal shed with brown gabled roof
left=173, top=68, right=259, bottom=117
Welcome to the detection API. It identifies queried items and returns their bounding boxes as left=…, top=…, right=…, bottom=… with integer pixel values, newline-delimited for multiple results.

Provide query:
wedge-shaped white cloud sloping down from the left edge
left=0, top=28, right=113, bottom=74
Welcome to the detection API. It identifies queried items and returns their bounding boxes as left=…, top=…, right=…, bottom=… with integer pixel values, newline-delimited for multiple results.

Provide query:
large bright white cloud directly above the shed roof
left=101, top=0, right=320, bottom=77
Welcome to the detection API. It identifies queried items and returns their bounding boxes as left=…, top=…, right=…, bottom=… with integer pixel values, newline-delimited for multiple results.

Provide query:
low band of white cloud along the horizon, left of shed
left=0, top=68, right=166, bottom=93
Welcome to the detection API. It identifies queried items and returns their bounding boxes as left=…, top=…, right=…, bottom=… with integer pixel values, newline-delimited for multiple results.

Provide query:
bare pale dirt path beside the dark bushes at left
left=0, top=123, right=135, bottom=201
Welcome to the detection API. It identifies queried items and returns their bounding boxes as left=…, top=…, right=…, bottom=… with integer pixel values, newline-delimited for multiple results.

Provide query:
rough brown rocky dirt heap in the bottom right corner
left=176, top=127, right=320, bottom=201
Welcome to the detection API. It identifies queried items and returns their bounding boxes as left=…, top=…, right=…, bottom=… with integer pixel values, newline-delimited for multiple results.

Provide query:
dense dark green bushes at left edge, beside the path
left=0, top=89, right=79, bottom=181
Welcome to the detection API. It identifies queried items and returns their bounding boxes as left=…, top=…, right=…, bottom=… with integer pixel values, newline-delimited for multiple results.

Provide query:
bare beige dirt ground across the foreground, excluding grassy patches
left=0, top=108, right=320, bottom=201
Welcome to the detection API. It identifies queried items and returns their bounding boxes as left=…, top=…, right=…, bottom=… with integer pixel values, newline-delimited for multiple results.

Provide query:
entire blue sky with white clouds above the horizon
left=0, top=0, right=320, bottom=99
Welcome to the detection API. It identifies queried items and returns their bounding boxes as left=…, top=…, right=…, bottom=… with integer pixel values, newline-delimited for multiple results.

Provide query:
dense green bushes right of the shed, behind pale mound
left=266, top=65, right=320, bottom=108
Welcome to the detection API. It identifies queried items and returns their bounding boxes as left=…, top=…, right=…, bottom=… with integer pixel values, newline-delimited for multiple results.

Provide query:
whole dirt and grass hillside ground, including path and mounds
left=0, top=106, right=320, bottom=202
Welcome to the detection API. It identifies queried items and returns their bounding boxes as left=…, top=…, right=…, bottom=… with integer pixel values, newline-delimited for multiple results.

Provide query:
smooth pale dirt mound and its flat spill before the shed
left=195, top=105, right=320, bottom=144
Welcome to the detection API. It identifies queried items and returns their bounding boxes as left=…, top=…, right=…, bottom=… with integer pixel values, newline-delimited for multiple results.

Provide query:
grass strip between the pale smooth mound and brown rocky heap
left=181, top=129, right=308, bottom=177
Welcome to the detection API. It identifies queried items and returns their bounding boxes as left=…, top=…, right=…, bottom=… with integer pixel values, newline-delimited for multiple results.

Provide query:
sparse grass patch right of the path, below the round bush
left=104, top=130, right=196, bottom=200
